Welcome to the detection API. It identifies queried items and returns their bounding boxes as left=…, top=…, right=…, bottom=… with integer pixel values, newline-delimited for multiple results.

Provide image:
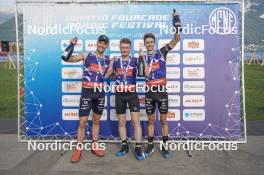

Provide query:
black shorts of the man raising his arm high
left=145, top=85, right=169, bottom=115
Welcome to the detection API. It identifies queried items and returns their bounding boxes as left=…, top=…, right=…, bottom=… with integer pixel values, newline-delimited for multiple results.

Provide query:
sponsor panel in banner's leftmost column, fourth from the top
left=62, top=81, right=82, bottom=93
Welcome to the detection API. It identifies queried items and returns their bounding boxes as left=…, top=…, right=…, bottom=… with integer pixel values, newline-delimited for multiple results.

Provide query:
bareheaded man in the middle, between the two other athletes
left=104, top=38, right=145, bottom=160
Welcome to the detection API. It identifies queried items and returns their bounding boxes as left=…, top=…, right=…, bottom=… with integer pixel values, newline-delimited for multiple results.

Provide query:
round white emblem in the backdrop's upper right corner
left=209, top=7, right=237, bottom=35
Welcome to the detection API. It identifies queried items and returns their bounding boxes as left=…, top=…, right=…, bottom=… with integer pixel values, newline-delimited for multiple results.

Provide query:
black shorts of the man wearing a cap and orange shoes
left=79, top=88, right=105, bottom=117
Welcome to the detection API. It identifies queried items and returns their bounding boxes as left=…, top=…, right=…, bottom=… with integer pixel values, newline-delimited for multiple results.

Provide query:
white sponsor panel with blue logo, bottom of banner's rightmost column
left=182, top=109, right=205, bottom=121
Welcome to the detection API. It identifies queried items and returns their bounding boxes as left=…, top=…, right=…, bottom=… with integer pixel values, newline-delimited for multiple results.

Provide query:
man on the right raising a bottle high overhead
left=140, top=10, right=181, bottom=158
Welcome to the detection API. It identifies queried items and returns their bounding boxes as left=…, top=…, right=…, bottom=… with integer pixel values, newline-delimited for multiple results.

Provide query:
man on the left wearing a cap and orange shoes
left=62, top=35, right=110, bottom=163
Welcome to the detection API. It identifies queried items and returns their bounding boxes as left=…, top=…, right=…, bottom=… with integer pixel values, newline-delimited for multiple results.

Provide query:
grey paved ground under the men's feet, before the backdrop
left=0, top=134, right=264, bottom=175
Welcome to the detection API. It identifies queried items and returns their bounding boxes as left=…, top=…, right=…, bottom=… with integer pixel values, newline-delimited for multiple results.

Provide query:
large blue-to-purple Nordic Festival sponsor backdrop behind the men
left=23, top=3, right=240, bottom=139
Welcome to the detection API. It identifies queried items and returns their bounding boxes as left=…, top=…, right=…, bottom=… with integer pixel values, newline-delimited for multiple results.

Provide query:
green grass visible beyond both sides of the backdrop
left=0, top=63, right=264, bottom=120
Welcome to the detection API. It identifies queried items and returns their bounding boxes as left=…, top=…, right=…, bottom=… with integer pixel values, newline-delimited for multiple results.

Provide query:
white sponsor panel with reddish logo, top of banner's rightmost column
left=183, top=39, right=204, bottom=51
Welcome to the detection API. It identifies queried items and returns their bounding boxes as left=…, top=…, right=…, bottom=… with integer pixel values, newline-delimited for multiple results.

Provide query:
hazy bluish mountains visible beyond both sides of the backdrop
left=0, top=0, right=264, bottom=51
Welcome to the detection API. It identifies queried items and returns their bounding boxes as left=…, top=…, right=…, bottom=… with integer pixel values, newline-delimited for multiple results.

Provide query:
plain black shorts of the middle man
left=115, top=92, right=139, bottom=114
